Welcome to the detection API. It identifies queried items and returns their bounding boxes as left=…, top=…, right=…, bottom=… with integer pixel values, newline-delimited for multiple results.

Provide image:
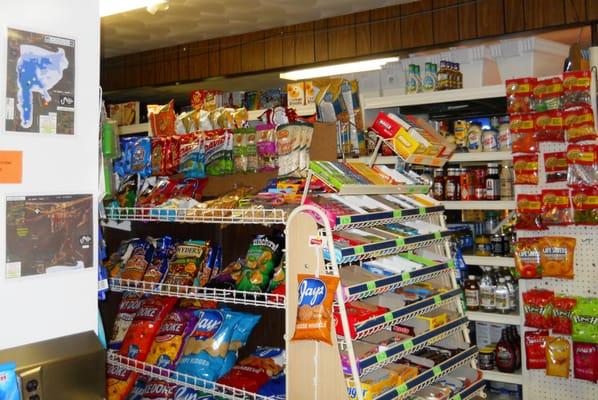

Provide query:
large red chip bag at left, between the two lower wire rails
left=120, top=296, right=177, bottom=361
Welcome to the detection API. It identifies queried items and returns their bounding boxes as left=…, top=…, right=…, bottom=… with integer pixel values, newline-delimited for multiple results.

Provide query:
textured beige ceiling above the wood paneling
left=102, top=0, right=413, bottom=57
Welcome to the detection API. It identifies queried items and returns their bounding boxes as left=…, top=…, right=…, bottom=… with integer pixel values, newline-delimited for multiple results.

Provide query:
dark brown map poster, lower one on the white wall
left=6, top=194, right=94, bottom=278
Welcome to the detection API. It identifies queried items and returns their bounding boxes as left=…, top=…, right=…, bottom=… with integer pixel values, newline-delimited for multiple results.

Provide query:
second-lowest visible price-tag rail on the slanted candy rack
left=374, top=346, right=478, bottom=400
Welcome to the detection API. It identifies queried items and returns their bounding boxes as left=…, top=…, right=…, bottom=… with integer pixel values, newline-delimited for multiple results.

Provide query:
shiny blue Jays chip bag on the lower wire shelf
left=176, top=309, right=241, bottom=381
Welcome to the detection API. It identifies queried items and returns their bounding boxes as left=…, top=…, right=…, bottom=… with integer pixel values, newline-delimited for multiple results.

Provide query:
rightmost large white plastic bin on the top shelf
left=490, top=37, right=569, bottom=81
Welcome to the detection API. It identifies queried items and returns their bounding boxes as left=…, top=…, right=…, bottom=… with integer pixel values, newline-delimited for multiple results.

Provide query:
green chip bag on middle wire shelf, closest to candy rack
left=237, top=235, right=282, bottom=292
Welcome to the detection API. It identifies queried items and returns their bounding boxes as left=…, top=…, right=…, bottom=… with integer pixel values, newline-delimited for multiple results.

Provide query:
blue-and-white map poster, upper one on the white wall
left=6, top=28, right=75, bottom=135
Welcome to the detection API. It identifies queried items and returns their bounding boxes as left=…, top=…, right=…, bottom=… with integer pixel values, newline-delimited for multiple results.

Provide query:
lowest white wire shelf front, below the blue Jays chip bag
left=107, top=351, right=273, bottom=400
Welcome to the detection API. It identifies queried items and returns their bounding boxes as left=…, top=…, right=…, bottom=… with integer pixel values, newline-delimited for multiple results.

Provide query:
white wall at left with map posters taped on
left=0, top=0, right=100, bottom=349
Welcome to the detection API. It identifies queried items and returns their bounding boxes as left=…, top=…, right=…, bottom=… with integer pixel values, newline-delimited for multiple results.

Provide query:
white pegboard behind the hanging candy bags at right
left=515, top=143, right=598, bottom=400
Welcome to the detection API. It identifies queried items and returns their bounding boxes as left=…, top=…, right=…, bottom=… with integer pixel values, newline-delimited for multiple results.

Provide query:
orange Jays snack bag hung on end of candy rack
left=291, top=274, right=339, bottom=344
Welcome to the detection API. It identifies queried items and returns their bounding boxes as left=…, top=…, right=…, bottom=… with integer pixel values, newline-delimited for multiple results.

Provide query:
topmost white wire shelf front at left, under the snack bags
left=106, top=207, right=286, bottom=224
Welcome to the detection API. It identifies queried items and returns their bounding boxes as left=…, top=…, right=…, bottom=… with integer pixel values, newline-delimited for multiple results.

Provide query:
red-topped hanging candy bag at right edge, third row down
left=567, top=144, right=598, bottom=187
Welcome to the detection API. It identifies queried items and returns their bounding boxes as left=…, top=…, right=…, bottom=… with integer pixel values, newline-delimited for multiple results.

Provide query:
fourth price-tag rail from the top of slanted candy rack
left=355, top=288, right=461, bottom=339
